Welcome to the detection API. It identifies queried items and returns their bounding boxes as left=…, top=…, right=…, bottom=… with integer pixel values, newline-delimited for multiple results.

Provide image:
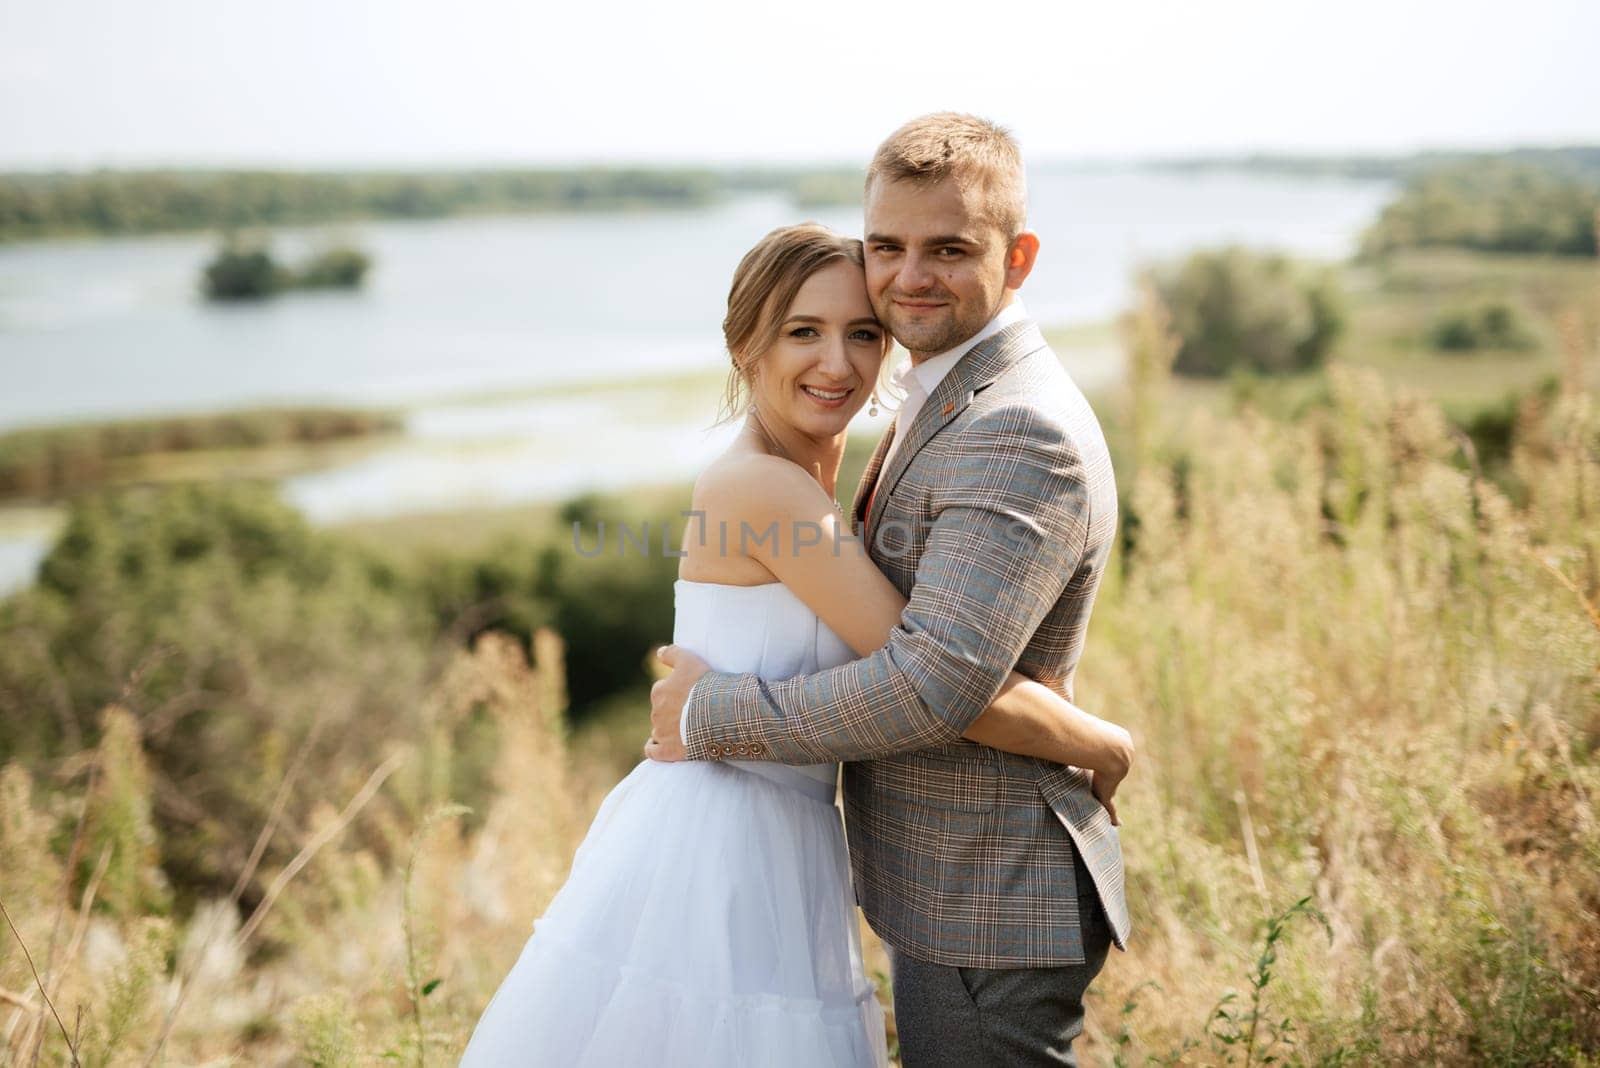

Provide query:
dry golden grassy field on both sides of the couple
left=0, top=247, right=1600, bottom=1065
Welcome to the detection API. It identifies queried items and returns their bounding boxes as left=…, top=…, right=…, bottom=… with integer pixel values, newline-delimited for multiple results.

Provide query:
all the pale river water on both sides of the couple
left=0, top=164, right=1392, bottom=588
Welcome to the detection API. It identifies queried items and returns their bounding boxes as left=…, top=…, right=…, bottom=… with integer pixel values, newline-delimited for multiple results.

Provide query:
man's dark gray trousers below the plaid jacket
left=888, top=862, right=1110, bottom=1068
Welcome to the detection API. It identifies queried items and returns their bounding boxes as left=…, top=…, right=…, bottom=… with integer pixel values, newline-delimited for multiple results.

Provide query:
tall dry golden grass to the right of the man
left=1080, top=287, right=1600, bottom=1063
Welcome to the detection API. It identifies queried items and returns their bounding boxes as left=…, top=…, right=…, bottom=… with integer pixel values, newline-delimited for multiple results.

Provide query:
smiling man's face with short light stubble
left=866, top=177, right=1010, bottom=360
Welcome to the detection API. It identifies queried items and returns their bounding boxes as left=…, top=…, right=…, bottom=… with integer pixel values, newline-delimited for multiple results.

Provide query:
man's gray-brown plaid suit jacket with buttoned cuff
left=683, top=320, right=1128, bottom=967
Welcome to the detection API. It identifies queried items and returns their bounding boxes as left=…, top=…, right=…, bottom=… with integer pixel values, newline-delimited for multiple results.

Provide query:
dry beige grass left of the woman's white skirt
left=0, top=633, right=594, bottom=1065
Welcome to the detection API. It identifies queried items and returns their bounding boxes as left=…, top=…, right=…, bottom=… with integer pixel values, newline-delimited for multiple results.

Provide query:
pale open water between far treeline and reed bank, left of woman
left=0, top=200, right=812, bottom=428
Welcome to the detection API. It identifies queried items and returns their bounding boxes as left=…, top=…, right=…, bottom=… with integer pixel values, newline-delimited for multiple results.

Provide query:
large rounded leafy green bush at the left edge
left=0, top=484, right=432, bottom=899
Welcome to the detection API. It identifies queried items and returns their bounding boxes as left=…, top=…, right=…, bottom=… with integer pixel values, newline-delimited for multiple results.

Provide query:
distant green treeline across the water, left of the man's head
left=0, top=168, right=861, bottom=241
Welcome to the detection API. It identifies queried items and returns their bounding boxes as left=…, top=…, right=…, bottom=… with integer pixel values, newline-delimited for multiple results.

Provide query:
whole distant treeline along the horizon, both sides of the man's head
left=0, top=145, right=1600, bottom=253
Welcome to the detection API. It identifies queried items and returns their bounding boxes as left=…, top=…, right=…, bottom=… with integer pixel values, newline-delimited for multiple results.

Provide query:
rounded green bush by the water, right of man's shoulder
left=1154, top=248, right=1344, bottom=377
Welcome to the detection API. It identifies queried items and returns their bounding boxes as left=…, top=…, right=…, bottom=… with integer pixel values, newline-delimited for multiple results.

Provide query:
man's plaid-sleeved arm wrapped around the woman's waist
left=682, top=406, right=1090, bottom=764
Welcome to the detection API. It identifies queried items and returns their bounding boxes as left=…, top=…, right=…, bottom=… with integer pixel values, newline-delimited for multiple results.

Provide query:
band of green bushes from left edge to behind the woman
left=0, top=483, right=678, bottom=908
